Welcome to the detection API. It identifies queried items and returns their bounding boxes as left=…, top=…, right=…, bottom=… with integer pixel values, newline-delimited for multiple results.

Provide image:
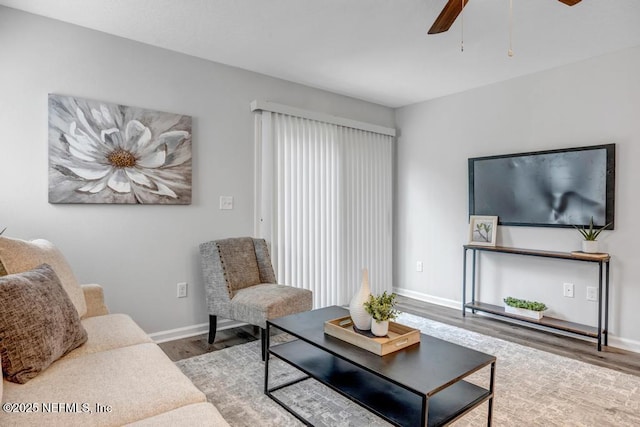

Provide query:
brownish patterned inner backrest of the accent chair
left=216, top=237, right=260, bottom=298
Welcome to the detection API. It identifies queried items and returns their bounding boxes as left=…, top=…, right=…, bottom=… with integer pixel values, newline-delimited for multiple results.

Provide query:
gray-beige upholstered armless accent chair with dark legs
left=200, top=237, right=313, bottom=360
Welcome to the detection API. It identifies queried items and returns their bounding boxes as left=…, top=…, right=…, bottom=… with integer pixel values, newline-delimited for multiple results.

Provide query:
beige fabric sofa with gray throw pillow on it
left=0, top=237, right=228, bottom=426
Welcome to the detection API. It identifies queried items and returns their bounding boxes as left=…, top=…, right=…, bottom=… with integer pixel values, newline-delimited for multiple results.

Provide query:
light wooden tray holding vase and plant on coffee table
left=324, top=316, right=420, bottom=356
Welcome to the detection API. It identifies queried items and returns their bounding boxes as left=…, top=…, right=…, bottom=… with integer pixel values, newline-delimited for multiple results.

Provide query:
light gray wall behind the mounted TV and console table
left=394, top=47, right=640, bottom=351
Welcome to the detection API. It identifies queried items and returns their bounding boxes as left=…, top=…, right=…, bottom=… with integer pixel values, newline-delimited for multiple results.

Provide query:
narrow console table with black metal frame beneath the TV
left=462, top=245, right=611, bottom=351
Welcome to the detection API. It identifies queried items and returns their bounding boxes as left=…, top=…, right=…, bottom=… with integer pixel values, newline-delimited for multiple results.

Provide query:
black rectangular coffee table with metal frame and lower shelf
left=264, top=306, right=496, bottom=426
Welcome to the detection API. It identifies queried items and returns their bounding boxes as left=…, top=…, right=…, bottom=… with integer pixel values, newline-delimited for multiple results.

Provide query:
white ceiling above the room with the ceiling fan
left=0, top=0, right=640, bottom=107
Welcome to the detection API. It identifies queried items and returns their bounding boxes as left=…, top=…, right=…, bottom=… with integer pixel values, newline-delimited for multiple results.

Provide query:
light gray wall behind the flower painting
left=0, top=7, right=394, bottom=333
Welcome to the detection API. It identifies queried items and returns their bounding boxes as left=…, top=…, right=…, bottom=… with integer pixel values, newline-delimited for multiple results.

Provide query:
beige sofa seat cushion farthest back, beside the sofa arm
left=64, top=314, right=153, bottom=359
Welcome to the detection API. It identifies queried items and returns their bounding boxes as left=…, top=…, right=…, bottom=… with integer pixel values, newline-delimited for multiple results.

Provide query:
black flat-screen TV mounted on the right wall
left=469, top=144, right=616, bottom=230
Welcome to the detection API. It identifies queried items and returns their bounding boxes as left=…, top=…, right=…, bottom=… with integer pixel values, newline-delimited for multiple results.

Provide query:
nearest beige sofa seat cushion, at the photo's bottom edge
left=127, top=403, right=229, bottom=427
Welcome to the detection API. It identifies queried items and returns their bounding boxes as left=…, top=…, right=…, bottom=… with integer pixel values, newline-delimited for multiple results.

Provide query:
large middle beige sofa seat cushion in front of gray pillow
left=0, top=343, right=206, bottom=426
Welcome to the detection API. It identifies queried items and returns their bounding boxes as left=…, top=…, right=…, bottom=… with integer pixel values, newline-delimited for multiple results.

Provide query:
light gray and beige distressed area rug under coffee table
left=177, top=313, right=640, bottom=427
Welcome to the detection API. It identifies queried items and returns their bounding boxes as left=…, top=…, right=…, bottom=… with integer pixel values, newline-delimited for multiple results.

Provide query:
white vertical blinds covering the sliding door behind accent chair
left=256, top=107, right=393, bottom=308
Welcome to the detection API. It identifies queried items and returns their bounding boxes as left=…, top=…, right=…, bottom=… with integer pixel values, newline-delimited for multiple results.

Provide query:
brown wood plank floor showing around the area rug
left=160, top=297, right=640, bottom=376
